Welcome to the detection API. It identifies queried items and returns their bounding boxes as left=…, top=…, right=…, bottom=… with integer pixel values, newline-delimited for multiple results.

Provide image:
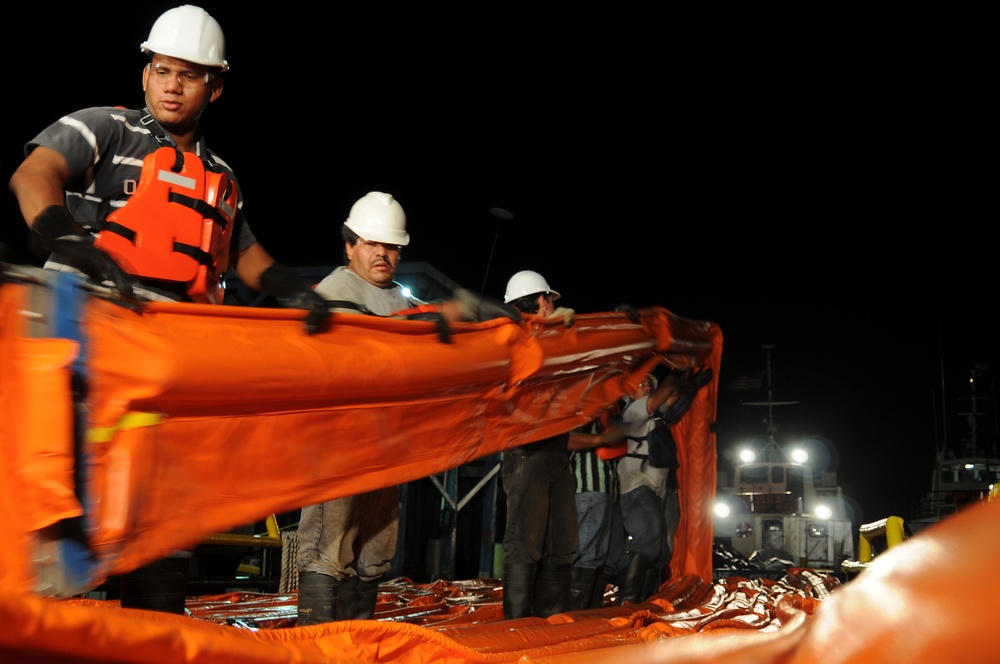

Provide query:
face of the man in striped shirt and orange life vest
left=142, top=53, right=222, bottom=132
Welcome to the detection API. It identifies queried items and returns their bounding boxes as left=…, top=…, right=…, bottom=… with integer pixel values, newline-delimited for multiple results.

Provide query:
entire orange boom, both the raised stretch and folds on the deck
left=0, top=269, right=1000, bottom=664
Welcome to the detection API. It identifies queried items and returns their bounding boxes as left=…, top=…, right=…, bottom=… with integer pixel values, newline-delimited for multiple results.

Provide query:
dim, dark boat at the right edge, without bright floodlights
left=906, top=363, right=1000, bottom=535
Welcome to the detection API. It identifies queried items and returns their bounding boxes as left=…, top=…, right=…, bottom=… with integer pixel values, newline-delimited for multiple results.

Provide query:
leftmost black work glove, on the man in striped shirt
left=31, top=205, right=135, bottom=299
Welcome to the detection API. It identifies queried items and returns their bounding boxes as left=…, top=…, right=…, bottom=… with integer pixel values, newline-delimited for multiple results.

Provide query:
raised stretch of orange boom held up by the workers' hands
left=0, top=268, right=722, bottom=597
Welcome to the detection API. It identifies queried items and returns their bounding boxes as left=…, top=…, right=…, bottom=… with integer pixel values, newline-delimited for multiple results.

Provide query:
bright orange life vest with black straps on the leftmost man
left=94, top=147, right=237, bottom=304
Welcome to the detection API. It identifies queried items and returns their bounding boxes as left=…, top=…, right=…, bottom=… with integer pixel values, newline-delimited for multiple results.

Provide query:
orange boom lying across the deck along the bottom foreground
left=0, top=501, right=1000, bottom=664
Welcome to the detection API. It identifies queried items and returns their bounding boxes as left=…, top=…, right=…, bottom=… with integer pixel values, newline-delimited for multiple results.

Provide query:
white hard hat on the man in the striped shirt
left=139, top=5, right=229, bottom=71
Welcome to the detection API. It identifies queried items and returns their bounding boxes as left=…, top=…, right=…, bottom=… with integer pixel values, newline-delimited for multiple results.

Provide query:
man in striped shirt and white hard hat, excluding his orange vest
left=9, top=5, right=329, bottom=613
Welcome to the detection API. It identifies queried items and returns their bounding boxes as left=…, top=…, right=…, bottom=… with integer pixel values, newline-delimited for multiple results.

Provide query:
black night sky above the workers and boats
left=0, top=2, right=1000, bottom=522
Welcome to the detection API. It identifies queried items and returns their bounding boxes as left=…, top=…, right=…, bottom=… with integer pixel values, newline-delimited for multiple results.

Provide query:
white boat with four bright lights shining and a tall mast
left=713, top=345, right=854, bottom=578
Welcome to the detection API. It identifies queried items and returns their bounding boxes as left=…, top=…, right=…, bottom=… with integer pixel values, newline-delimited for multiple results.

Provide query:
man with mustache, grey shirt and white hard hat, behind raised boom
left=296, top=191, right=521, bottom=626
